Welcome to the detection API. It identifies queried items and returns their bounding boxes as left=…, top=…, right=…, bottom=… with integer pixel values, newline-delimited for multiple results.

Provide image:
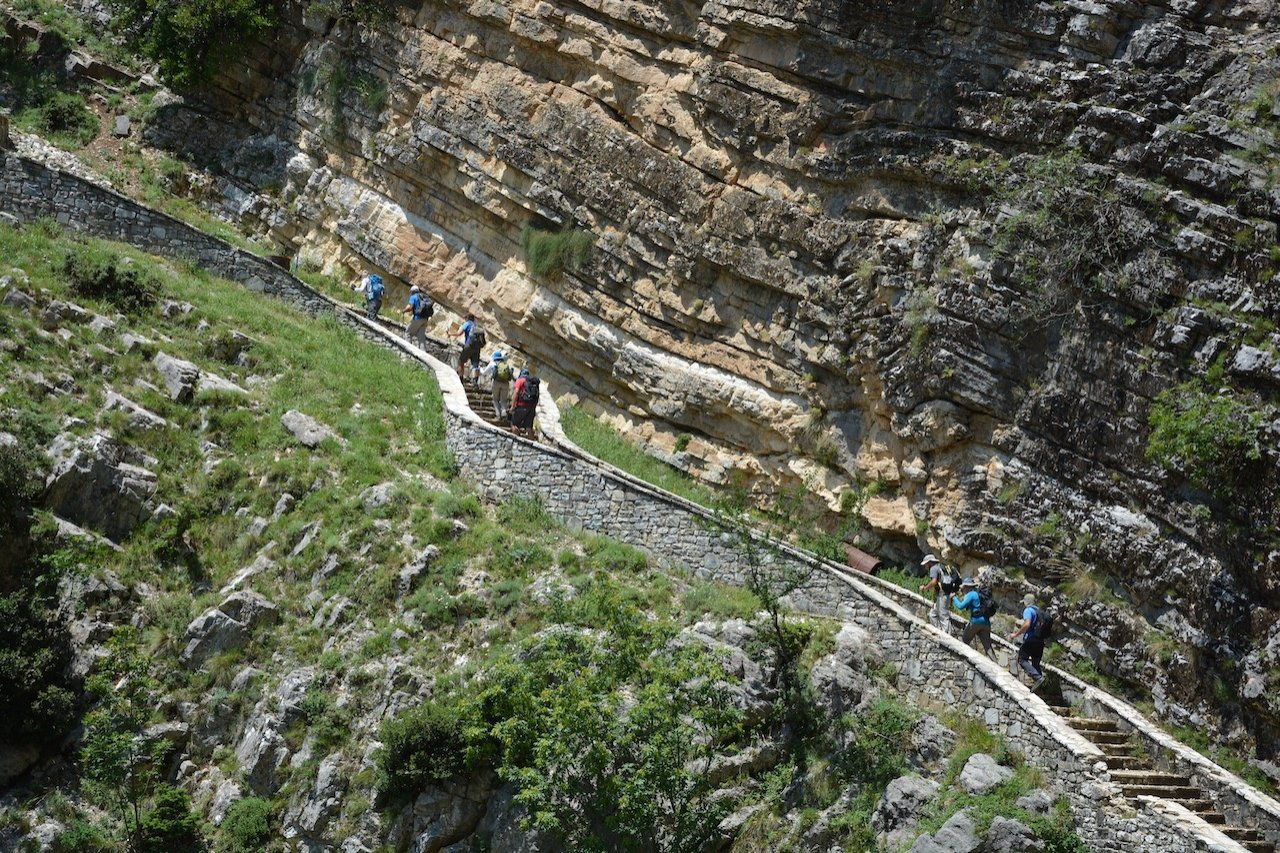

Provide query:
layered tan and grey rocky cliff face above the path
left=150, top=0, right=1280, bottom=758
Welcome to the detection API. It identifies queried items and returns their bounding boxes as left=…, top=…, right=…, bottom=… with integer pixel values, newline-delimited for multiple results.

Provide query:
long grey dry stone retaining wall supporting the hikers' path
left=0, top=154, right=1272, bottom=853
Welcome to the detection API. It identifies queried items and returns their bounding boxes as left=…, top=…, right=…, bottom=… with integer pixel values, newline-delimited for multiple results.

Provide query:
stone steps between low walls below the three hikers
left=1050, top=704, right=1276, bottom=853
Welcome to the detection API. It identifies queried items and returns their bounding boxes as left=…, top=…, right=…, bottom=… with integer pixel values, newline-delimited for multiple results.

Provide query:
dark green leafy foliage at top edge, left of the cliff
left=108, top=0, right=276, bottom=88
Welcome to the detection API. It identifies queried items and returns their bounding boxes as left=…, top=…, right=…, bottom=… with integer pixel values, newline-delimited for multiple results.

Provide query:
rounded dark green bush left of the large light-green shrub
left=378, top=701, right=470, bottom=800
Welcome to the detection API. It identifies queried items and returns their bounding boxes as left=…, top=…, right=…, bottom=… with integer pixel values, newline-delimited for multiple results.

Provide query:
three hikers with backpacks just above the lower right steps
left=920, top=553, right=1053, bottom=692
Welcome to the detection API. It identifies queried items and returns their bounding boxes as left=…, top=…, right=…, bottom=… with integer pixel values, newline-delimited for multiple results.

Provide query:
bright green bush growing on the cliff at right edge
left=1147, top=364, right=1266, bottom=498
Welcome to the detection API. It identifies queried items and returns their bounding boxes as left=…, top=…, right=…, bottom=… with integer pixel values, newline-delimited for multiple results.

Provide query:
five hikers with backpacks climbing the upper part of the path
left=352, top=273, right=541, bottom=438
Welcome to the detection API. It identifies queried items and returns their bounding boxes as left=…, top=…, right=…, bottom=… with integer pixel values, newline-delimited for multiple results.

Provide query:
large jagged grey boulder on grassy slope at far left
left=44, top=433, right=156, bottom=542
